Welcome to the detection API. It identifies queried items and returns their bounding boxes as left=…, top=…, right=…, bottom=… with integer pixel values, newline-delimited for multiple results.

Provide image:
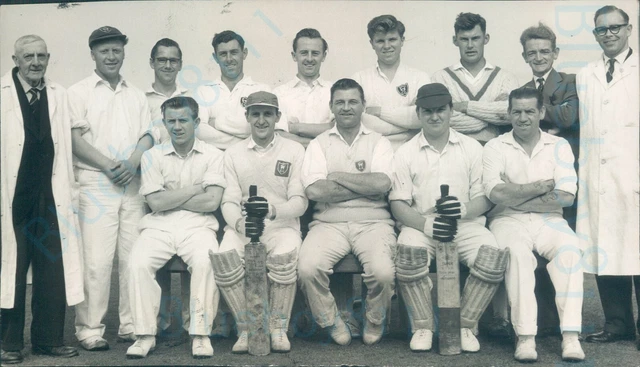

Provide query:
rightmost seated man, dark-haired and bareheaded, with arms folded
left=483, top=87, right=584, bottom=362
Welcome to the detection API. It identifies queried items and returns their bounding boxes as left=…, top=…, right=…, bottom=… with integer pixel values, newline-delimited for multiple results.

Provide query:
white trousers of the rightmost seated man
left=489, top=213, right=583, bottom=335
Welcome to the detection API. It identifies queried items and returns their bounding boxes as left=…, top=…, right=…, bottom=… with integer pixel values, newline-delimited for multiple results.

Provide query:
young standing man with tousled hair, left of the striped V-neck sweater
left=352, top=15, right=431, bottom=150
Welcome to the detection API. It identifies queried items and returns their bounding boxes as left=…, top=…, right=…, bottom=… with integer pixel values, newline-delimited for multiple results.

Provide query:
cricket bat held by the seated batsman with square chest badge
left=244, top=185, right=271, bottom=356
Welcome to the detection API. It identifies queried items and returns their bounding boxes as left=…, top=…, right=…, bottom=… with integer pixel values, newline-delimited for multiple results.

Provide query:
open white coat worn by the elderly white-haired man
left=0, top=71, right=84, bottom=308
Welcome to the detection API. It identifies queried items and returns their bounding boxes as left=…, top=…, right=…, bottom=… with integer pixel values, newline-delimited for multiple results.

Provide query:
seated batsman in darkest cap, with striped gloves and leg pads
left=389, top=83, right=508, bottom=352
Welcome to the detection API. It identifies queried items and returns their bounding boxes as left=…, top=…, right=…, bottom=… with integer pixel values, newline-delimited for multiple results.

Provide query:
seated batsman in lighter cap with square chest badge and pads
left=211, top=91, right=308, bottom=353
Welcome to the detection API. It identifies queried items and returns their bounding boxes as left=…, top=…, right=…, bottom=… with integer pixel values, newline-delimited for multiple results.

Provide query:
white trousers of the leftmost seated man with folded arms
left=129, top=224, right=220, bottom=335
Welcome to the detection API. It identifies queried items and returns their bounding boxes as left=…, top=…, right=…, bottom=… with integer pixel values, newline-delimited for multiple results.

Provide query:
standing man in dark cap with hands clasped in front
left=68, top=27, right=153, bottom=351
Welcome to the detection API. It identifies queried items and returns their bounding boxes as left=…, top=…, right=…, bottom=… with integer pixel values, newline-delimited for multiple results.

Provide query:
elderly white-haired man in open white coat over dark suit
left=0, top=35, right=84, bottom=365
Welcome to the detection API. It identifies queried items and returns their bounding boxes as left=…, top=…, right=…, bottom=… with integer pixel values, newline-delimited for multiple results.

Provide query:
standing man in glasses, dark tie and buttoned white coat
left=576, top=5, right=640, bottom=343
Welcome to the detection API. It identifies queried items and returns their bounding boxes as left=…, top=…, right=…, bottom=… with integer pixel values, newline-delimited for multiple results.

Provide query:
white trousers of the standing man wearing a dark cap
left=75, top=169, right=145, bottom=341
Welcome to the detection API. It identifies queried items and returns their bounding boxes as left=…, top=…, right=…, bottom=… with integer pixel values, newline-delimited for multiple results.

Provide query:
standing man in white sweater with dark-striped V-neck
left=433, top=13, right=518, bottom=145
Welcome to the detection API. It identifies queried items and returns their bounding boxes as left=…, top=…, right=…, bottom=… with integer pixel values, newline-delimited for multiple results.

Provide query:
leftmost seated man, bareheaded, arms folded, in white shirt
left=127, top=96, right=225, bottom=358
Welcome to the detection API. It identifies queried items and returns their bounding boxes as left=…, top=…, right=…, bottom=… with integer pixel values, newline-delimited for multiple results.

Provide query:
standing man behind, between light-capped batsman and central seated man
left=273, top=28, right=335, bottom=148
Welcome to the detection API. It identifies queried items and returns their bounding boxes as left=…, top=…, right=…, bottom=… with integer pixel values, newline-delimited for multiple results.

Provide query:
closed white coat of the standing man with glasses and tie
left=576, top=50, right=640, bottom=275
